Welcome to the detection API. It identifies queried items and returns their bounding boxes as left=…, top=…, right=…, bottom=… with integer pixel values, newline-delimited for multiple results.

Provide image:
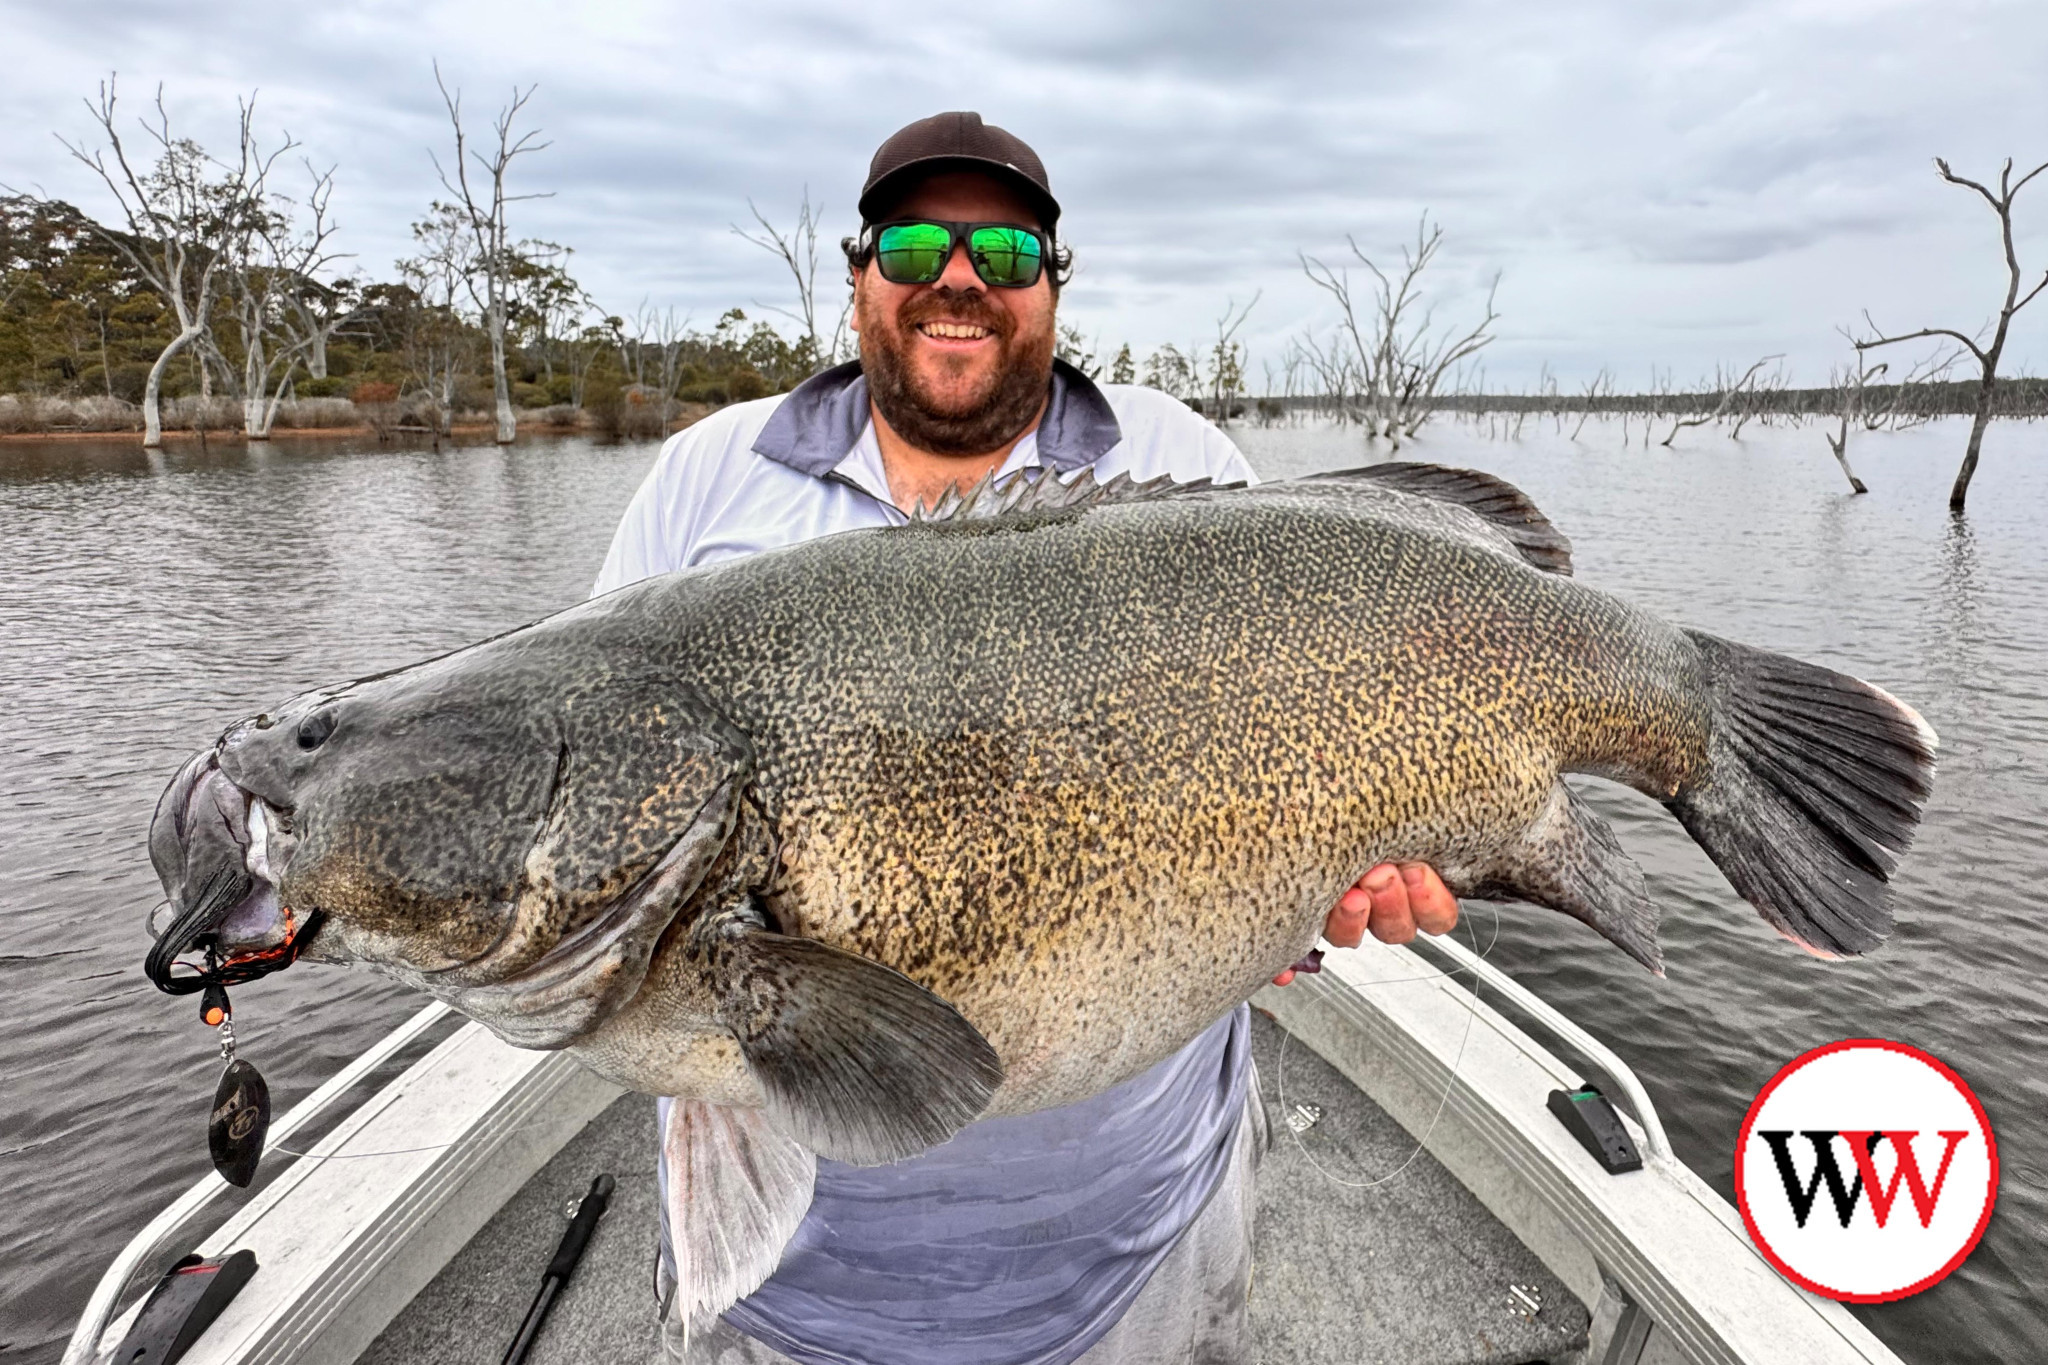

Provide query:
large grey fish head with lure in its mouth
left=150, top=647, right=748, bottom=1048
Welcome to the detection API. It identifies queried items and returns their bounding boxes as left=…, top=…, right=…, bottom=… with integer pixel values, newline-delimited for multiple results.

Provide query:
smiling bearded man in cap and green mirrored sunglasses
left=596, top=113, right=1458, bottom=1365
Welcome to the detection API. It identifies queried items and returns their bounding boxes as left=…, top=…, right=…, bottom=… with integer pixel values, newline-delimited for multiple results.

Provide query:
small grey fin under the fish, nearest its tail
left=1460, top=782, right=1663, bottom=976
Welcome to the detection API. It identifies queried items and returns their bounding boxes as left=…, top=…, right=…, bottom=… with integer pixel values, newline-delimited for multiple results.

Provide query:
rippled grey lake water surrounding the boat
left=0, top=422, right=2048, bottom=1361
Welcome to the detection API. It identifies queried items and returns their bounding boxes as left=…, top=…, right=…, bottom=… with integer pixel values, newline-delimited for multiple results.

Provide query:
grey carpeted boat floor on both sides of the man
left=358, top=1013, right=1587, bottom=1365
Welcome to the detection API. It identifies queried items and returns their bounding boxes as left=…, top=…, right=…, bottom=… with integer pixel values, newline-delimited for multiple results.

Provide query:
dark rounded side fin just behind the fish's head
left=690, top=896, right=1004, bottom=1166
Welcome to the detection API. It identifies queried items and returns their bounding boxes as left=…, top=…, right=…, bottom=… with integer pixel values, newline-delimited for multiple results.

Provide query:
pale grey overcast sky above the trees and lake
left=0, top=0, right=2048, bottom=387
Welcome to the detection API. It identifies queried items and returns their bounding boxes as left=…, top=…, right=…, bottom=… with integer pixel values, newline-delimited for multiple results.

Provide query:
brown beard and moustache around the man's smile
left=860, top=289, right=1053, bottom=454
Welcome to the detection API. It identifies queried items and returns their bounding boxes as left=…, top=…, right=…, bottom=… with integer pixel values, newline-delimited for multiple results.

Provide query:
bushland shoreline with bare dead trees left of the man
left=0, top=82, right=829, bottom=444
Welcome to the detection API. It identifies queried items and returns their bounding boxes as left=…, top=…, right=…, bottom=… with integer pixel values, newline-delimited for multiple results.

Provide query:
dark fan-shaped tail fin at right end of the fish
left=1667, top=630, right=1939, bottom=958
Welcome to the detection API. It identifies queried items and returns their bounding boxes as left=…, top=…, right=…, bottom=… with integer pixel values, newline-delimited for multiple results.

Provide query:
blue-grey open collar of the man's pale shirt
left=754, top=360, right=1124, bottom=479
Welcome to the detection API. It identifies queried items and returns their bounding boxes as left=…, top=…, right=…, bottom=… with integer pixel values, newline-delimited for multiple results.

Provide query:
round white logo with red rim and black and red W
left=1735, top=1038, right=1999, bottom=1304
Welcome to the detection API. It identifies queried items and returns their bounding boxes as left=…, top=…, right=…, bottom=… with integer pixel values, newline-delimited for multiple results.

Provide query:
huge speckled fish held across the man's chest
left=140, top=463, right=1935, bottom=1312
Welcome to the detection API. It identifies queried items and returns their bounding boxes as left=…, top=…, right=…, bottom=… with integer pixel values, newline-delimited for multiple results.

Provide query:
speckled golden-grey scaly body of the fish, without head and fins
left=563, top=485, right=1706, bottom=1113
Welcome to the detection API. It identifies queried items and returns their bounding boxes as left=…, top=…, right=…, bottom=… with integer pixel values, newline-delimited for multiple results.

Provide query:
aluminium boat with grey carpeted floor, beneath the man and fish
left=63, top=939, right=1896, bottom=1365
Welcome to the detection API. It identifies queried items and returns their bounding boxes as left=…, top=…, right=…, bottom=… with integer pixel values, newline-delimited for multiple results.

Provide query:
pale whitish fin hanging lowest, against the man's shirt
left=662, top=1099, right=817, bottom=1328
